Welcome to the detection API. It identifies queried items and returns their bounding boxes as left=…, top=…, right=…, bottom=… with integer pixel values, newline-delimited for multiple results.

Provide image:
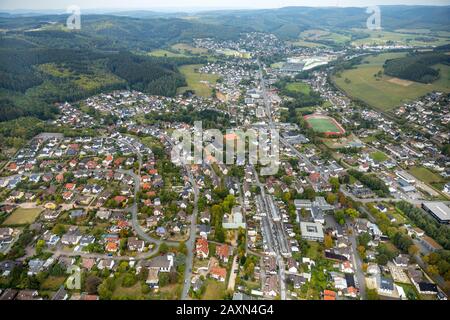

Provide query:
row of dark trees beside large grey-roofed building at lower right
left=396, top=201, right=450, bottom=250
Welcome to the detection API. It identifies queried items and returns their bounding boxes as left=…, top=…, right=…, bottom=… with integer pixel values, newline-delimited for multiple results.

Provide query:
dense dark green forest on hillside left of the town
left=0, top=42, right=204, bottom=121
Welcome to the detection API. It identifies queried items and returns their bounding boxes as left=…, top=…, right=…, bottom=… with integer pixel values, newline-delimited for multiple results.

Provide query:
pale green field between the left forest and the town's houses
left=178, top=64, right=219, bottom=98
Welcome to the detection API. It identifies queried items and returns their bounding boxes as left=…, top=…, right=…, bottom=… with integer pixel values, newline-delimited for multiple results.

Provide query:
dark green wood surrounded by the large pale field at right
left=384, top=52, right=450, bottom=83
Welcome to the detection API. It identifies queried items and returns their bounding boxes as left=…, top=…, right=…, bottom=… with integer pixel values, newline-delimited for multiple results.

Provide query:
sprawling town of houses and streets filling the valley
left=0, top=4, right=450, bottom=300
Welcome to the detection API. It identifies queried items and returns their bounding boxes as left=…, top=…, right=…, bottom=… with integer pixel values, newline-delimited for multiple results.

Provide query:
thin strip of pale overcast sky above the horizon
left=0, top=0, right=450, bottom=10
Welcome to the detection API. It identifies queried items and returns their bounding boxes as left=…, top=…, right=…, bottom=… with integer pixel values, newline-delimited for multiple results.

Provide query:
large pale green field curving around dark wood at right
left=333, top=52, right=450, bottom=111
